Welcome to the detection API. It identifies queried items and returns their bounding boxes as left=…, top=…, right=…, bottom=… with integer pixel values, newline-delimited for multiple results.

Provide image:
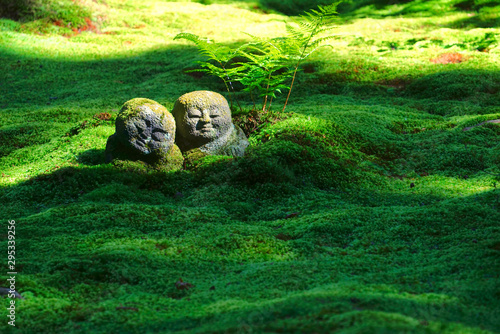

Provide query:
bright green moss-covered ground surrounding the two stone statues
left=0, top=0, right=500, bottom=333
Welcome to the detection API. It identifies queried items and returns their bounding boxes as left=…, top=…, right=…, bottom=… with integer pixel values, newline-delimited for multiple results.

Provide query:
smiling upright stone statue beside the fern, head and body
left=172, top=91, right=248, bottom=157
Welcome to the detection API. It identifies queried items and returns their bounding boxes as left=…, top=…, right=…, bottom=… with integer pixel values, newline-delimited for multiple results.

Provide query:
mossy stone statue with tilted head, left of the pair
left=105, top=98, right=183, bottom=169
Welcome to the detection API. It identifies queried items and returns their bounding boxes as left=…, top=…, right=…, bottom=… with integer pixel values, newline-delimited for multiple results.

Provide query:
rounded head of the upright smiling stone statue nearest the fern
left=172, top=91, right=233, bottom=148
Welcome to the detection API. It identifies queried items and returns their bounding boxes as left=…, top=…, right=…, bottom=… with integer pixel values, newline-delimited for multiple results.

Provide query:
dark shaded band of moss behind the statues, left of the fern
left=0, top=42, right=225, bottom=111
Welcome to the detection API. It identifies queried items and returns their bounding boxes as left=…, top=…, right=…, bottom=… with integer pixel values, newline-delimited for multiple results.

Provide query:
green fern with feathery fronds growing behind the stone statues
left=174, top=1, right=341, bottom=112
